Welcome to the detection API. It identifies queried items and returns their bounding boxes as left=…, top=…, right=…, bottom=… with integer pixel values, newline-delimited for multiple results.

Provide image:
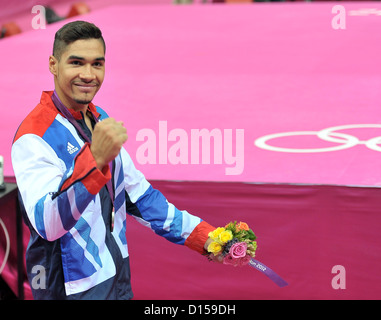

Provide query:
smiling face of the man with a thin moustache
left=49, top=39, right=105, bottom=111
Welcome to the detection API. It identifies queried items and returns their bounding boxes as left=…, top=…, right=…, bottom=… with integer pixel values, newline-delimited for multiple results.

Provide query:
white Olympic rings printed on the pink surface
left=254, top=124, right=381, bottom=153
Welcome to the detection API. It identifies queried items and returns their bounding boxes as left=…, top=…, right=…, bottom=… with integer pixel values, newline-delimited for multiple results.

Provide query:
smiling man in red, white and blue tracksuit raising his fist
left=12, top=21, right=214, bottom=300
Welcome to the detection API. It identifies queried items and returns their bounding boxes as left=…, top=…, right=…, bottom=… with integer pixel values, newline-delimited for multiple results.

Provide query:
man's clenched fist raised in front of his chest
left=90, top=118, right=128, bottom=170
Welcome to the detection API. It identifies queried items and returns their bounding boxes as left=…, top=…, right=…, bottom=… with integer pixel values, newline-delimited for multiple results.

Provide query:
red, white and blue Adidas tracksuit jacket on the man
left=12, top=91, right=214, bottom=299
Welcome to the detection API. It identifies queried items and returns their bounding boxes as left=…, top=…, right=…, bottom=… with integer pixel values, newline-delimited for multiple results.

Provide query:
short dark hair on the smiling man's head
left=53, top=21, right=106, bottom=60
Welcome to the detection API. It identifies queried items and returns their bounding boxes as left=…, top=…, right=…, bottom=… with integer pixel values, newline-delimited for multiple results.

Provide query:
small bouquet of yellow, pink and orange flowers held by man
left=208, top=221, right=257, bottom=266
